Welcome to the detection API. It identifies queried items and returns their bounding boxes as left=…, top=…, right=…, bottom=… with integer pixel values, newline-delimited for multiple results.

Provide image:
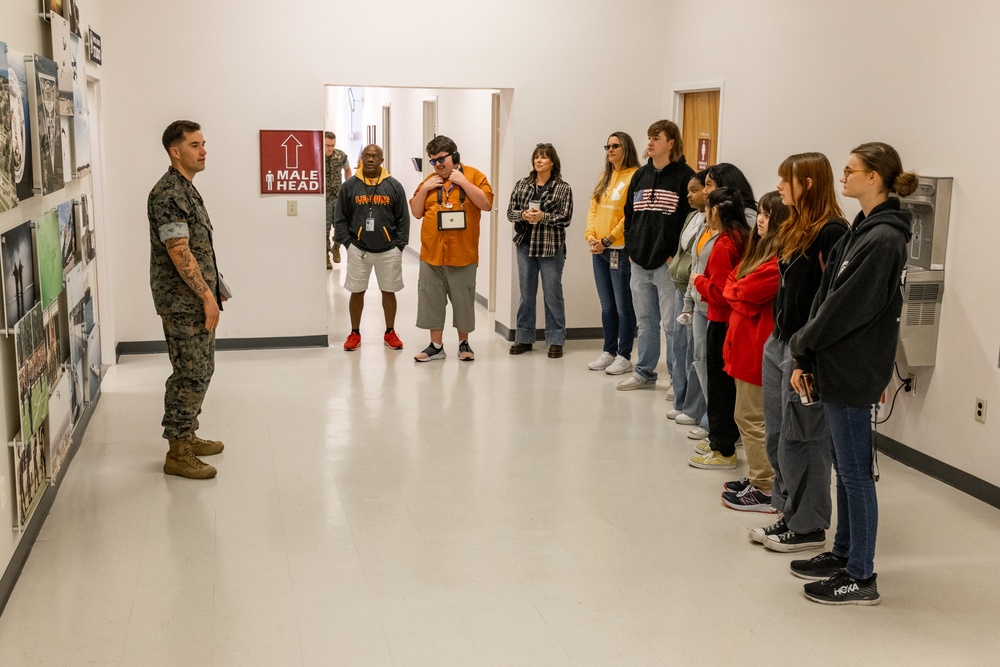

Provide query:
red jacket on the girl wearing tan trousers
left=728, top=258, right=779, bottom=386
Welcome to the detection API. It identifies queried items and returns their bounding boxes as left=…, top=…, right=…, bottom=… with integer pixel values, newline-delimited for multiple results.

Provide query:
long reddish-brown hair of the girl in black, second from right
left=778, top=153, right=844, bottom=262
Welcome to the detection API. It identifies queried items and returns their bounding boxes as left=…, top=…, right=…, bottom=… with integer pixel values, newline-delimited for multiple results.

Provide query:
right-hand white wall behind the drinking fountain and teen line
left=662, top=0, right=1000, bottom=484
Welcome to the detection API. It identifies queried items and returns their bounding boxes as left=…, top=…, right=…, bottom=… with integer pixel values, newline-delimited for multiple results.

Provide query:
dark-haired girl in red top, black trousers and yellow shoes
left=688, top=188, right=747, bottom=470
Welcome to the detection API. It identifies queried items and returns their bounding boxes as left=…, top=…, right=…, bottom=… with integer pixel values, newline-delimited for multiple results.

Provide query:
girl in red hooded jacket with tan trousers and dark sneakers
left=722, top=190, right=788, bottom=514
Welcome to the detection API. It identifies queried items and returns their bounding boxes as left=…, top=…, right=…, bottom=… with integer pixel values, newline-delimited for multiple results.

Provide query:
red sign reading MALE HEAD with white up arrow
left=260, top=130, right=324, bottom=195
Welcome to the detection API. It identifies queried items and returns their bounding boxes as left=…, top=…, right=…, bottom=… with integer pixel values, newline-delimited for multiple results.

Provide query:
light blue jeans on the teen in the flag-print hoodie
left=630, top=264, right=675, bottom=382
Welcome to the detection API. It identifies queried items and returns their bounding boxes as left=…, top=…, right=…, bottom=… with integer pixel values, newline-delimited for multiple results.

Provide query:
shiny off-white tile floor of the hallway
left=0, top=253, right=1000, bottom=667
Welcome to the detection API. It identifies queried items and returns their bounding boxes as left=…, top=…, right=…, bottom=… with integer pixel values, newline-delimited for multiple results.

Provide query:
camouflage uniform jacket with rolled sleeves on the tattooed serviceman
left=146, top=167, right=222, bottom=315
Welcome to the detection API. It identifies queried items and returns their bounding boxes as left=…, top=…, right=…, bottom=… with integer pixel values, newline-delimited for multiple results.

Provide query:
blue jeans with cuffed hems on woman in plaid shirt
left=514, top=244, right=566, bottom=345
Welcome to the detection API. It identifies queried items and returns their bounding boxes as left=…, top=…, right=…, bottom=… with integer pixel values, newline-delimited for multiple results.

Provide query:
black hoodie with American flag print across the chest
left=625, top=155, right=694, bottom=271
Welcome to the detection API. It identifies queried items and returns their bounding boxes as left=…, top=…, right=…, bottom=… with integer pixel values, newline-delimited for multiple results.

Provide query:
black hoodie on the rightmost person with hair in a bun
left=791, top=199, right=913, bottom=407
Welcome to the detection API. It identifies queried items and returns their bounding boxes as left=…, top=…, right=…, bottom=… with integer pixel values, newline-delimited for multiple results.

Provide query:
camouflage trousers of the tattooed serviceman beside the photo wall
left=161, top=313, right=215, bottom=440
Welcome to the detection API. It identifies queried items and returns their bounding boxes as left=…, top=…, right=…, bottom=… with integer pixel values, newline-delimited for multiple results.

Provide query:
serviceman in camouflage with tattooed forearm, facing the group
left=147, top=121, right=223, bottom=479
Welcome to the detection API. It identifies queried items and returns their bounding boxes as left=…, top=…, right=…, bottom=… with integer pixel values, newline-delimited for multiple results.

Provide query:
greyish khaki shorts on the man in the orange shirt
left=417, top=261, right=478, bottom=332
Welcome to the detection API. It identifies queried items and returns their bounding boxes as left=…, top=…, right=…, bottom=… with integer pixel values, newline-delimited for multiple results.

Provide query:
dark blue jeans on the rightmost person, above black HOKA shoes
left=823, top=403, right=878, bottom=579
